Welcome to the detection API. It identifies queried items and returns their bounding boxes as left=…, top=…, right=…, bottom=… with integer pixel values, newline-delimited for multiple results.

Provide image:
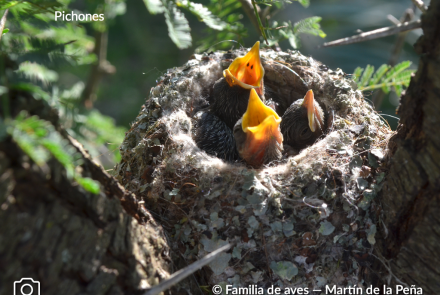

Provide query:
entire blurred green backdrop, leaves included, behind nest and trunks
left=0, top=0, right=428, bottom=173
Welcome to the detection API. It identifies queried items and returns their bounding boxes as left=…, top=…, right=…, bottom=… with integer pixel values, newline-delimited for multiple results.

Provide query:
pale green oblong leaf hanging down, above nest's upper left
left=164, top=2, right=192, bottom=49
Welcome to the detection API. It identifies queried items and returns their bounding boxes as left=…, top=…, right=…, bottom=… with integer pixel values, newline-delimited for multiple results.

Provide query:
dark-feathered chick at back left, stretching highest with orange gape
left=195, top=42, right=264, bottom=161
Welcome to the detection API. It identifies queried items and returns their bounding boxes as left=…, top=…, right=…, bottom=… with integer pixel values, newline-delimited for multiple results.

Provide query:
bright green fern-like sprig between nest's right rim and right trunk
left=353, top=61, right=415, bottom=96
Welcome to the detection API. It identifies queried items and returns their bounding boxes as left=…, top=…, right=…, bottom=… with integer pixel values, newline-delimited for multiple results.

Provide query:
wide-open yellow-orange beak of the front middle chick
left=239, top=89, right=283, bottom=166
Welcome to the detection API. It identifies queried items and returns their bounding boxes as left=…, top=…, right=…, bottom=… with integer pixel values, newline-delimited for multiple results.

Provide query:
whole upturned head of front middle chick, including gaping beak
left=234, top=89, right=283, bottom=167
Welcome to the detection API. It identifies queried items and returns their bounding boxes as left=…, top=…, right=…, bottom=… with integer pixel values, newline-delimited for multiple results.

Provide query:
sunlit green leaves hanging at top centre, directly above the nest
left=143, top=0, right=325, bottom=52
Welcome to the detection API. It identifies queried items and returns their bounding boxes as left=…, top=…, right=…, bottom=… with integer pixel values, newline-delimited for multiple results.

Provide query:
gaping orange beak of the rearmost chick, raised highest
left=223, top=41, right=264, bottom=95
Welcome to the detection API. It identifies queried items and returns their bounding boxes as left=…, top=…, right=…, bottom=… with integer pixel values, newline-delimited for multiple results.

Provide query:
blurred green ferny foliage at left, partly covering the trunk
left=0, top=0, right=125, bottom=193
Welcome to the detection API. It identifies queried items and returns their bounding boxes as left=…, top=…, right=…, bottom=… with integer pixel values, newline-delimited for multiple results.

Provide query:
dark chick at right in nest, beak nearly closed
left=281, top=90, right=325, bottom=150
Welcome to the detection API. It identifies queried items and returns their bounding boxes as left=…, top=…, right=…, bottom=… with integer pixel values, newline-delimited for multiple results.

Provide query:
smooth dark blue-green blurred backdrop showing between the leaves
left=83, top=0, right=421, bottom=128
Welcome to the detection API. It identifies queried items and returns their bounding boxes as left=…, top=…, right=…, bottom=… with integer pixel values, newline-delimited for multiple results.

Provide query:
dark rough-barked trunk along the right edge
left=382, top=0, right=440, bottom=294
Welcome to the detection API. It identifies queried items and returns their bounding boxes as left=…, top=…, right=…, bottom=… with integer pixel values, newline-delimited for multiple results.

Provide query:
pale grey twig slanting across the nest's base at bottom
left=144, top=244, right=232, bottom=295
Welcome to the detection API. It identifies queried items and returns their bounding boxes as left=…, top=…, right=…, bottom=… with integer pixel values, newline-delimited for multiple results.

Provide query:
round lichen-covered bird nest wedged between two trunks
left=115, top=50, right=392, bottom=292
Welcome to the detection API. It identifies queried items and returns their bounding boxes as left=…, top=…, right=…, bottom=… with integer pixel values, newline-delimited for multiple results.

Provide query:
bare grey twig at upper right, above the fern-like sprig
left=321, top=20, right=422, bottom=47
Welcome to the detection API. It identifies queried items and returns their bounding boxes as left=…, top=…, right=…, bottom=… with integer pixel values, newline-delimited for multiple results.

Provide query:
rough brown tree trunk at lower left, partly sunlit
left=0, top=93, right=170, bottom=295
